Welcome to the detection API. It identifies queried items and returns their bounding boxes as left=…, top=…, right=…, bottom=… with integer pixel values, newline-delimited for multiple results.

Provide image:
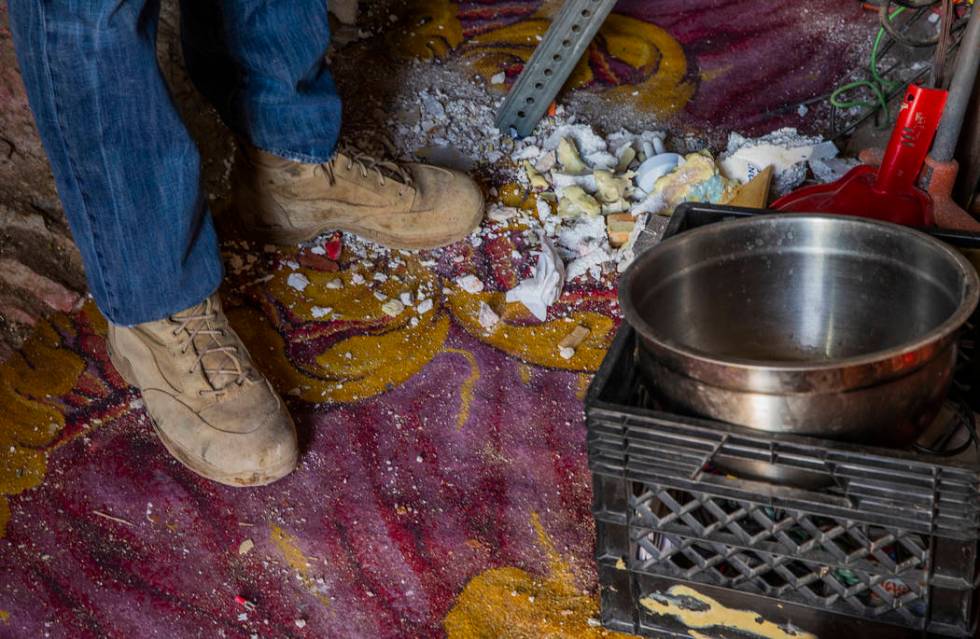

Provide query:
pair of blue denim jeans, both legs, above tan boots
left=9, top=0, right=340, bottom=325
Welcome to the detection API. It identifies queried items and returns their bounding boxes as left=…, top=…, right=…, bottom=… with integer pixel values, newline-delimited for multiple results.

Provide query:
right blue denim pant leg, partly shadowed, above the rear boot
left=181, top=0, right=341, bottom=162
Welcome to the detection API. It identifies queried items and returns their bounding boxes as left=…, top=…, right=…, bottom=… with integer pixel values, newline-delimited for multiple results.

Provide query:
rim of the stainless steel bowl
left=619, top=213, right=980, bottom=373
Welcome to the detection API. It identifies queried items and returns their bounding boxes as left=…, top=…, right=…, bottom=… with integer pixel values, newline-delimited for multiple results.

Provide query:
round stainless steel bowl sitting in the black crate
left=619, top=214, right=980, bottom=445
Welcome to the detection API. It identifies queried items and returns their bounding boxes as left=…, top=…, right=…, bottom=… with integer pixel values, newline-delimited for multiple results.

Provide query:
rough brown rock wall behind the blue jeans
left=0, top=0, right=357, bottom=361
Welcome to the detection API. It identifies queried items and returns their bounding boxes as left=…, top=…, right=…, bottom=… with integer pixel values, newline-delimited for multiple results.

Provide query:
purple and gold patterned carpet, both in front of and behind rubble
left=0, top=0, right=866, bottom=639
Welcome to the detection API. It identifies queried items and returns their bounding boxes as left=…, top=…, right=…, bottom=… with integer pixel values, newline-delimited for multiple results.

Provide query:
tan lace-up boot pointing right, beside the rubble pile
left=232, top=146, right=483, bottom=249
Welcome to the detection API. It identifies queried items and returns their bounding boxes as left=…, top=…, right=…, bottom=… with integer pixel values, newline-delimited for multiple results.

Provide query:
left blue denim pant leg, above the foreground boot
left=9, top=0, right=222, bottom=324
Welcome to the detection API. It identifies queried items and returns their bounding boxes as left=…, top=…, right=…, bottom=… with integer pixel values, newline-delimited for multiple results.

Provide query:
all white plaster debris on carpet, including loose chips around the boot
left=220, top=68, right=854, bottom=338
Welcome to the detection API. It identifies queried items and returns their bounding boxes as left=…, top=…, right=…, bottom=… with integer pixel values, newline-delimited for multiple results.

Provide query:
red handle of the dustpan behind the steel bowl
left=873, top=84, right=947, bottom=193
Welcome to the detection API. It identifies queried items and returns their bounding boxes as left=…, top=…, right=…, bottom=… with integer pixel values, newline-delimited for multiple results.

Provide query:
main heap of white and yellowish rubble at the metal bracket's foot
left=378, top=70, right=850, bottom=321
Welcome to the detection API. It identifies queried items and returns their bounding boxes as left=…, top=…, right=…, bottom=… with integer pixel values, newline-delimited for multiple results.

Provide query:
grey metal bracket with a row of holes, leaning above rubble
left=497, top=0, right=616, bottom=137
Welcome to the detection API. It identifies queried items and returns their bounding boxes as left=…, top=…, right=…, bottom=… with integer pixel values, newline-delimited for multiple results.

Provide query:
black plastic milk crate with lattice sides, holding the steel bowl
left=586, top=205, right=980, bottom=639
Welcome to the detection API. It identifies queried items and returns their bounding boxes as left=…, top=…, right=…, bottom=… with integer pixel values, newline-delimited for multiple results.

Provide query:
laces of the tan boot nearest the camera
left=170, top=299, right=256, bottom=397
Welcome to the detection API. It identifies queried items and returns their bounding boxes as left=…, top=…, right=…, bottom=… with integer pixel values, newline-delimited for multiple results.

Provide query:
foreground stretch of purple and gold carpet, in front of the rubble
left=0, top=239, right=613, bottom=637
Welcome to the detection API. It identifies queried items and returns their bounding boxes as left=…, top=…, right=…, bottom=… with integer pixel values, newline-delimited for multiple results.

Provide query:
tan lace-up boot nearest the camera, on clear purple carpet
left=108, top=294, right=298, bottom=486
